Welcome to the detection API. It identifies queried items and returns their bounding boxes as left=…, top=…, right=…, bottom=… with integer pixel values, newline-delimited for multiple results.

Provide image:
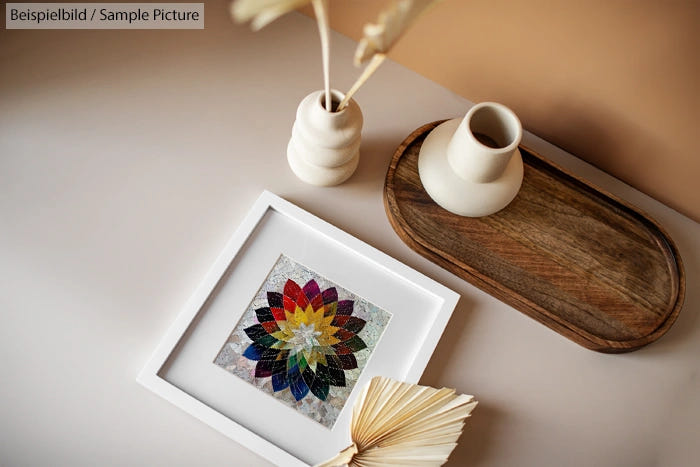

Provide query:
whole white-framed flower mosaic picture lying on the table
left=137, top=192, right=459, bottom=466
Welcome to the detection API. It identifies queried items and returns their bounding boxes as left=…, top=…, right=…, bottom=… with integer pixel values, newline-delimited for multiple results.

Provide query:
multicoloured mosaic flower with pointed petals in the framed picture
left=243, top=279, right=367, bottom=401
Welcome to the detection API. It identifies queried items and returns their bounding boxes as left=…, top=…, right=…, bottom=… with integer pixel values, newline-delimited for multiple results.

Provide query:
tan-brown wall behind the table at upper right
left=304, top=0, right=700, bottom=220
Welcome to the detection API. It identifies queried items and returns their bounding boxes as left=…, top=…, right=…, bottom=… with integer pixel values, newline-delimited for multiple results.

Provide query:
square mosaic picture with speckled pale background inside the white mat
left=214, top=255, right=391, bottom=428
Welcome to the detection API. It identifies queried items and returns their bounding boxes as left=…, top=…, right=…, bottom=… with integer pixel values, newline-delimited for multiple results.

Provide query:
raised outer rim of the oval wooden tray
left=383, top=119, right=685, bottom=353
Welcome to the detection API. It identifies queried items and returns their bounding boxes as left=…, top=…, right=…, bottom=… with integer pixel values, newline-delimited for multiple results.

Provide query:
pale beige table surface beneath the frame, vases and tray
left=0, top=6, right=700, bottom=467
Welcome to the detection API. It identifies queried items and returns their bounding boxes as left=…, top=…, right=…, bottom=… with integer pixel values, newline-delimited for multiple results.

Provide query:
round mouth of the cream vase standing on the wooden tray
left=469, top=106, right=520, bottom=149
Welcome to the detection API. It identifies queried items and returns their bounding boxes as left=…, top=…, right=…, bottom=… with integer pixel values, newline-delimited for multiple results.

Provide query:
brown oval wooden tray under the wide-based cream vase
left=384, top=122, right=685, bottom=353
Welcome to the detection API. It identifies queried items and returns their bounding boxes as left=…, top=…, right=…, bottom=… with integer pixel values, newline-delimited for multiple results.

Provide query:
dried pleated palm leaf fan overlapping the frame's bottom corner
left=316, top=376, right=477, bottom=467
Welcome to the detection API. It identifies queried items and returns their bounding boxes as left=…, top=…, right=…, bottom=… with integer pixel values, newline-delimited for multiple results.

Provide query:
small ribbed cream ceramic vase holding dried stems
left=287, top=90, right=363, bottom=186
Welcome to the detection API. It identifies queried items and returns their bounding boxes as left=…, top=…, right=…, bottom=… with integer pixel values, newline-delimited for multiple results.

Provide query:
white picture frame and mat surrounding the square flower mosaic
left=137, top=191, right=459, bottom=466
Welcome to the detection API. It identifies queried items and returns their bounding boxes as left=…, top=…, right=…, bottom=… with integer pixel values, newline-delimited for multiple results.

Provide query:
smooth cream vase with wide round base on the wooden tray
left=418, top=102, right=523, bottom=217
